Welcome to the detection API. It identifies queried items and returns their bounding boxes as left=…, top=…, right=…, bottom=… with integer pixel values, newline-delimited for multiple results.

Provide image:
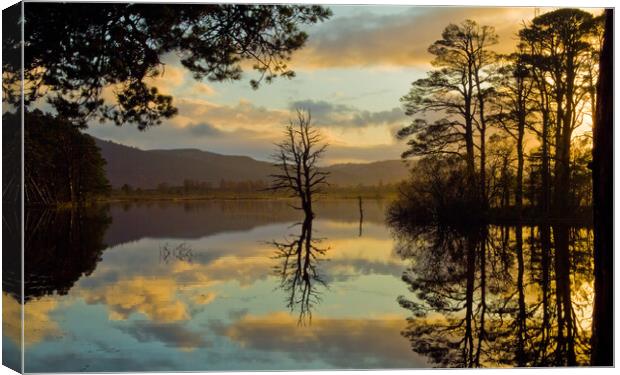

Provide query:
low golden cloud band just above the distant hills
left=87, top=93, right=407, bottom=164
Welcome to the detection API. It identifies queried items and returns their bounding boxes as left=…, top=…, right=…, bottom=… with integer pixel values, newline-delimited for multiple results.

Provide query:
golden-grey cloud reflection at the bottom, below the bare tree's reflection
left=212, top=313, right=424, bottom=369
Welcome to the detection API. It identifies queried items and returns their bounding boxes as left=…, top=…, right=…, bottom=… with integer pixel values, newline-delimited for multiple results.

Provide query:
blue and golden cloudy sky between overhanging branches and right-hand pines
left=87, top=6, right=560, bottom=164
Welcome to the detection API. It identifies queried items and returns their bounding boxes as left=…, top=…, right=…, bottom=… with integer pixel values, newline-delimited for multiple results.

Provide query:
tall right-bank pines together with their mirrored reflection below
left=389, top=9, right=613, bottom=367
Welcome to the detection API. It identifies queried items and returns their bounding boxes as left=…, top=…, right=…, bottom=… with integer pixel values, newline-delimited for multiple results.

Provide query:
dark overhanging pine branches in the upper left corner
left=3, top=3, right=331, bottom=129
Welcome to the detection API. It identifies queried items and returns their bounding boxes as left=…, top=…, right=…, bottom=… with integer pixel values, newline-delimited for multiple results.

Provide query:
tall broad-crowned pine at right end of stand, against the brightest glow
left=519, top=9, right=600, bottom=216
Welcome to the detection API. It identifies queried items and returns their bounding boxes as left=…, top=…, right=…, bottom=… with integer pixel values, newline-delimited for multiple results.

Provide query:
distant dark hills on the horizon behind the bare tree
left=95, top=138, right=408, bottom=189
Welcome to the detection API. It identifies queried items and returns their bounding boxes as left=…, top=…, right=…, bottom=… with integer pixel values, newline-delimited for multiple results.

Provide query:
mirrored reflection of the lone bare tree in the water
left=272, top=216, right=328, bottom=324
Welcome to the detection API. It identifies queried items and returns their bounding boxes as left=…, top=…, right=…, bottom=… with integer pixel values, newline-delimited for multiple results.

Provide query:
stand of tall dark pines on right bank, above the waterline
left=392, top=9, right=602, bottom=225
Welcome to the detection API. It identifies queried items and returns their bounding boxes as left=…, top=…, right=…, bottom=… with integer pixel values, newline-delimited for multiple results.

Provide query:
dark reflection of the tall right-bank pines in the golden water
left=395, top=225, right=593, bottom=367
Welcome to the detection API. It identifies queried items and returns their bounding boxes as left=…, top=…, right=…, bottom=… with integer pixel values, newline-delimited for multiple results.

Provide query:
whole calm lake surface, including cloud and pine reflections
left=3, top=200, right=592, bottom=372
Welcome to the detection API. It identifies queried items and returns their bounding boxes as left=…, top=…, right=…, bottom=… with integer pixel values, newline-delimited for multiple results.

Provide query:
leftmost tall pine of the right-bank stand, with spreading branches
left=398, top=20, right=497, bottom=210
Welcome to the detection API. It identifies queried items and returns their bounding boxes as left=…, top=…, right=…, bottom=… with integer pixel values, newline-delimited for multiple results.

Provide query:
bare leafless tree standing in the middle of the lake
left=270, top=109, right=329, bottom=217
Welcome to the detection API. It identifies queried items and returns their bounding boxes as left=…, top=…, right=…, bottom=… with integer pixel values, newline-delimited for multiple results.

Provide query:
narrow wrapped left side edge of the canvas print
left=2, top=2, right=24, bottom=372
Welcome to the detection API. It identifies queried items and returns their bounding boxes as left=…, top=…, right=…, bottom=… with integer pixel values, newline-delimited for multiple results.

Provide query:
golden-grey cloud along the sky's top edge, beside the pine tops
left=291, top=7, right=548, bottom=69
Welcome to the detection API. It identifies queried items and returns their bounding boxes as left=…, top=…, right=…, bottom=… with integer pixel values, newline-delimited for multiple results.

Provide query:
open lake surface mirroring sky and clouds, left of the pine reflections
left=12, top=200, right=424, bottom=372
